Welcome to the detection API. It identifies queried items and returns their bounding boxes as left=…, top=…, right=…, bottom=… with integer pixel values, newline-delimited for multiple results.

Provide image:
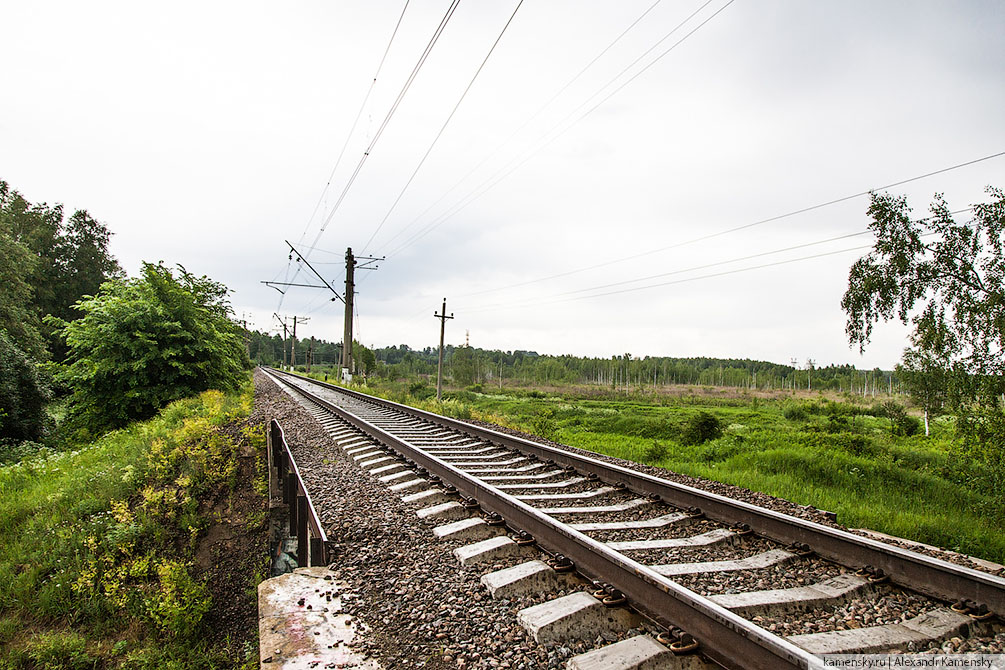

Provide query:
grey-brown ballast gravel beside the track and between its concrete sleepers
left=255, top=371, right=1005, bottom=670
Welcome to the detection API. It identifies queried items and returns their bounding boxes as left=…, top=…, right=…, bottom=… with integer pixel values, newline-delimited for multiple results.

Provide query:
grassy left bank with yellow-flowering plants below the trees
left=0, top=384, right=264, bottom=670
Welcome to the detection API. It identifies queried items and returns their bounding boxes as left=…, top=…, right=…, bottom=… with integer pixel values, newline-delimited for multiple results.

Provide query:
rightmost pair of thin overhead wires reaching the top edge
left=387, top=0, right=736, bottom=257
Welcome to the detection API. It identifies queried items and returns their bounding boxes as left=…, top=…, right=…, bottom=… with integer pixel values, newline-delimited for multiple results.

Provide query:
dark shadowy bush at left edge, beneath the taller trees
left=0, top=331, right=51, bottom=445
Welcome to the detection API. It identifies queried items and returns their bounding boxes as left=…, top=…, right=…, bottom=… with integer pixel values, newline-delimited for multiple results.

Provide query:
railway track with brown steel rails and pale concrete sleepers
left=266, top=370, right=1005, bottom=668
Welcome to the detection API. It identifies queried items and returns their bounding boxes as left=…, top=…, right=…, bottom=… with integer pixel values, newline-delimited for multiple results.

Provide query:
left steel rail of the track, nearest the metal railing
left=269, top=371, right=817, bottom=670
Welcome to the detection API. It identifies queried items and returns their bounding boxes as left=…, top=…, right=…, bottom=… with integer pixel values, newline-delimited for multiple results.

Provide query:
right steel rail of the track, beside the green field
left=265, top=369, right=1005, bottom=613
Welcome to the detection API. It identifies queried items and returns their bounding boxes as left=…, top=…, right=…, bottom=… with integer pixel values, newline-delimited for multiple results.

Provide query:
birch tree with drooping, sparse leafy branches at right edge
left=841, top=187, right=1005, bottom=502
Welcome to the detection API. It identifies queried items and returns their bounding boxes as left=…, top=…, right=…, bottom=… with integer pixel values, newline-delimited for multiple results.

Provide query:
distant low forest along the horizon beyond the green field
left=248, top=330, right=900, bottom=395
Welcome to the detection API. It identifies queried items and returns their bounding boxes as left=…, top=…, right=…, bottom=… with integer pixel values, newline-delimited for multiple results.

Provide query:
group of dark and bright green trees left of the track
left=0, top=181, right=248, bottom=450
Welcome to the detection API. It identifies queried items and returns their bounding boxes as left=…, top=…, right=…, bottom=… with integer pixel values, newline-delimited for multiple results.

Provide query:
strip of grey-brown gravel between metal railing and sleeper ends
left=255, top=372, right=659, bottom=670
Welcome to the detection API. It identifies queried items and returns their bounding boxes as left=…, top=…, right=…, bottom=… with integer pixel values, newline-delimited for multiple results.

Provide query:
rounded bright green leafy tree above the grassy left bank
left=58, top=263, right=247, bottom=433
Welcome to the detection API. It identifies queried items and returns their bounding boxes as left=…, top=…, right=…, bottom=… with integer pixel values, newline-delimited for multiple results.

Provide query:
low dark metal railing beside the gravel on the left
left=267, top=419, right=329, bottom=568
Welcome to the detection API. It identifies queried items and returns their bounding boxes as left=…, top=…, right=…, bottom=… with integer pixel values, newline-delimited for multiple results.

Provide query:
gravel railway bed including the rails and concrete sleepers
left=259, top=367, right=1005, bottom=668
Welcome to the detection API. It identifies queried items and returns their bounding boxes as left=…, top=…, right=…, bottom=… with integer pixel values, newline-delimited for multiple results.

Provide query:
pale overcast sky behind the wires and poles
left=0, top=0, right=1005, bottom=368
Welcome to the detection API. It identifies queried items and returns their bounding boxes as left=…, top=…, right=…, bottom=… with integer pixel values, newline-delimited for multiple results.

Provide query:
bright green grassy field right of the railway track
left=313, top=371, right=1005, bottom=563
